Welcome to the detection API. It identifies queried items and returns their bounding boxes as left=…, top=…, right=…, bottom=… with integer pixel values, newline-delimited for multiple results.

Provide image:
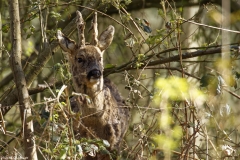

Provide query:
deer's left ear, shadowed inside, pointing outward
left=57, top=30, right=77, bottom=54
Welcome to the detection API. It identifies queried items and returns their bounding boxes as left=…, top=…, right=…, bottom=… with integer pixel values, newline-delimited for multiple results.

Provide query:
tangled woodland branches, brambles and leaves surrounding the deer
left=0, top=0, right=240, bottom=160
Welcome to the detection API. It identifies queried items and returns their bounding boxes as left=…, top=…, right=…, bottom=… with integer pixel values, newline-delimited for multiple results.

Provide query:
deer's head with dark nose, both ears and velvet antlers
left=57, top=11, right=115, bottom=95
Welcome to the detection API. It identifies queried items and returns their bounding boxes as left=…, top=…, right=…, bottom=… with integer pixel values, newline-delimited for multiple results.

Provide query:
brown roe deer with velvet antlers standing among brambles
left=57, top=11, right=129, bottom=159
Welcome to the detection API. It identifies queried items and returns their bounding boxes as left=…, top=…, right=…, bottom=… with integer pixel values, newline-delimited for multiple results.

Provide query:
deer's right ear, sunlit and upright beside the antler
left=98, top=25, right=115, bottom=51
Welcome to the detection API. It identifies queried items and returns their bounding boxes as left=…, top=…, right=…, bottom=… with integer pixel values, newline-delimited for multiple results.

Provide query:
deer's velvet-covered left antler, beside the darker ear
left=76, top=11, right=85, bottom=47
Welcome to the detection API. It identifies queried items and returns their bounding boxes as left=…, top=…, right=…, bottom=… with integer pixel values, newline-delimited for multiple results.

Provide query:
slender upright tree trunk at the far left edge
left=9, top=0, right=37, bottom=160
